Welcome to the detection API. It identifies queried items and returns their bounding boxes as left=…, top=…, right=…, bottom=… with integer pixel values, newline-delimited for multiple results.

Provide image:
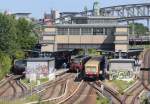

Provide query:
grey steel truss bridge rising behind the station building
left=61, top=3, right=150, bottom=34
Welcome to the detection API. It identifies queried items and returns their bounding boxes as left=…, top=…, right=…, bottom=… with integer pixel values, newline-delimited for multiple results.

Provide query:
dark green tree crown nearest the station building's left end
left=16, top=18, right=37, bottom=49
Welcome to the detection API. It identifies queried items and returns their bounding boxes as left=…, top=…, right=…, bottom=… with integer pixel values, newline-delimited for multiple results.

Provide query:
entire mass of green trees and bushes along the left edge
left=0, top=13, right=38, bottom=79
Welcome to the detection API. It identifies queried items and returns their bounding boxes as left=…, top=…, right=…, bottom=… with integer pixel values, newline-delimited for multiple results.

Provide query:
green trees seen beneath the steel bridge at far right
left=129, top=23, right=148, bottom=35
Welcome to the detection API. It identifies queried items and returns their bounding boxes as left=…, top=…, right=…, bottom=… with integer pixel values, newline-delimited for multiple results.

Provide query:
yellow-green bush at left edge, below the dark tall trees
left=0, top=52, right=12, bottom=79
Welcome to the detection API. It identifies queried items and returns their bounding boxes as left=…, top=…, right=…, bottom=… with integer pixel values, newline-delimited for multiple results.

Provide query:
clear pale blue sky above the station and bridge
left=0, top=0, right=150, bottom=18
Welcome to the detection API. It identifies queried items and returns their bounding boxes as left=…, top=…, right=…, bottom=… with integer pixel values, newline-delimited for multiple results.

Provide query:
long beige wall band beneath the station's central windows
left=56, top=35, right=114, bottom=44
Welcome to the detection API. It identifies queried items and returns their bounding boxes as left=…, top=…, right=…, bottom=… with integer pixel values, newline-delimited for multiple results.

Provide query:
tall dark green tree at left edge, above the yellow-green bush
left=0, top=13, right=18, bottom=55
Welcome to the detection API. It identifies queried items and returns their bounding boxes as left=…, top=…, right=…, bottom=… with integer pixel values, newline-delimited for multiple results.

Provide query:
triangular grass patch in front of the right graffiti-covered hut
left=109, top=80, right=134, bottom=93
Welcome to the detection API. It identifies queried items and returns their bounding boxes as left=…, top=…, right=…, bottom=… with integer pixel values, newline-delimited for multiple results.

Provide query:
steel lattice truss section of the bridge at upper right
left=101, top=4, right=150, bottom=18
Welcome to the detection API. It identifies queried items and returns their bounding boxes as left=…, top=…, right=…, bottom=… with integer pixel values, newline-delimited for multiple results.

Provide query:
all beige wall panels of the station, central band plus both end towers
left=41, top=27, right=128, bottom=52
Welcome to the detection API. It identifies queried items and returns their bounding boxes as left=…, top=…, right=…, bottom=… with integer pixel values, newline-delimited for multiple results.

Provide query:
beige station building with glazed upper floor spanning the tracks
left=40, top=3, right=129, bottom=52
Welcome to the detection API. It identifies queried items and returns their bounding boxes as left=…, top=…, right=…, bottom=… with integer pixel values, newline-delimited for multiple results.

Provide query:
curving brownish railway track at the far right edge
left=122, top=49, right=150, bottom=104
